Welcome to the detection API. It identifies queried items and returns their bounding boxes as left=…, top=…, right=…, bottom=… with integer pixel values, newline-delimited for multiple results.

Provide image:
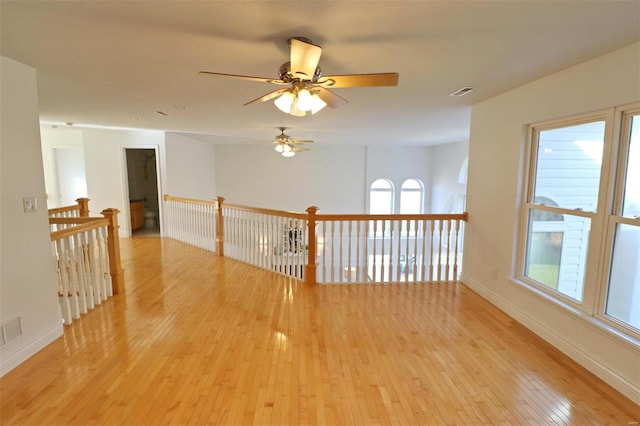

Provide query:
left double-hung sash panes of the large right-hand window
left=524, top=120, right=605, bottom=302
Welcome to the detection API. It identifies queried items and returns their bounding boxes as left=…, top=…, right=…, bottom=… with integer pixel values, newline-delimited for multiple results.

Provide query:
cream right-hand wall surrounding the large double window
left=462, top=44, right=640, bottom=403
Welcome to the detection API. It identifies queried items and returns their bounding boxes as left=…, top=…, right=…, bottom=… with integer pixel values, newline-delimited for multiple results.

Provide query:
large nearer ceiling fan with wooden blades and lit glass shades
left=198, top=37, right=398, bottom=117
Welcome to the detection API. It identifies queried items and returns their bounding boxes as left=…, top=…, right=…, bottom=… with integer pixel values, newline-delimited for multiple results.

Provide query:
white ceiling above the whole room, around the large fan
left=0, top=0, right=640, bottom=145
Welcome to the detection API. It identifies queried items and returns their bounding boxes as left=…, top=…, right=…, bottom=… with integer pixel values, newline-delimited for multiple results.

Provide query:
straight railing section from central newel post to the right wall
left=316, top=214, right=466, bottom=283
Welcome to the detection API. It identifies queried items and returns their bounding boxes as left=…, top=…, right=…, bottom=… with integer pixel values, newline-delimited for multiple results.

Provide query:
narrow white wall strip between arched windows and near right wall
left=430, top=141, right=469, bottom=213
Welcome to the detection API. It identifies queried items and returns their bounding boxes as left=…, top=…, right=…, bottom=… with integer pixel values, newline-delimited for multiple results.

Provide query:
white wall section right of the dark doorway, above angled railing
left=164, top=133, right=218, bottom=200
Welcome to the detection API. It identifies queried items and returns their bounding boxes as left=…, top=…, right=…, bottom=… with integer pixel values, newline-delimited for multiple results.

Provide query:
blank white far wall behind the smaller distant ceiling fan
left=215, top=144, right=366, bottom=214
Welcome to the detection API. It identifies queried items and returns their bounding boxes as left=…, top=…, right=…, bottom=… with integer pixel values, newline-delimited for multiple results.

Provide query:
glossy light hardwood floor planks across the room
left=0, top=237, right=640, bottom=425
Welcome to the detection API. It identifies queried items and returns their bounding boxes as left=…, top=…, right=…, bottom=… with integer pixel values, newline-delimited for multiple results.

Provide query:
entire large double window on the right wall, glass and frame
left=517, top=107, right=640, bottom=333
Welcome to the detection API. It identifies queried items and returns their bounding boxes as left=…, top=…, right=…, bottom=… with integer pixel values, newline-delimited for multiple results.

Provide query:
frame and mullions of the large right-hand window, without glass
left=514, top=104, right=640, bottom=341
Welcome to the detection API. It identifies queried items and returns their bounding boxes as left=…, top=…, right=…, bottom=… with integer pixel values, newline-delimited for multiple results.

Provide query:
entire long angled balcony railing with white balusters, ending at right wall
left=165, top=196, right=467, bottom=284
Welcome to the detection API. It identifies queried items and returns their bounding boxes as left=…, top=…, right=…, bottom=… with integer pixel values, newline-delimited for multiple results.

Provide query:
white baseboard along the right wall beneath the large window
left=460, top=276, right=640, bottom=405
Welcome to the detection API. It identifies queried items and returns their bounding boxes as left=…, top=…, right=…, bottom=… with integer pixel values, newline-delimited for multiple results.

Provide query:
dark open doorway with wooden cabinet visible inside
left=125, top=148, right=160, bottom=236
